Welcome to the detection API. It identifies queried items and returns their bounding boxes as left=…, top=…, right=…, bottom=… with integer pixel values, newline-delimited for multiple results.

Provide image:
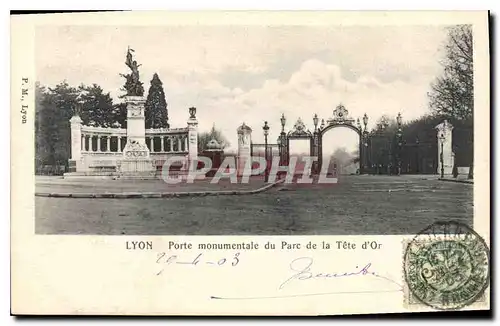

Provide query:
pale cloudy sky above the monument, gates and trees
left=36, top=25, right=446, bottom=152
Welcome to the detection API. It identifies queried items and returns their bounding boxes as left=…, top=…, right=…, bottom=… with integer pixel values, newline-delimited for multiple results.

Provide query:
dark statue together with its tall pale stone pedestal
left=117, top=48, right=156, bottom=176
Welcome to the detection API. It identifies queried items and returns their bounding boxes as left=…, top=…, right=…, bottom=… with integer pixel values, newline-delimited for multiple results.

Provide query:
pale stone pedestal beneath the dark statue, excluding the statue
left=118, top=96, right=156, bottom=175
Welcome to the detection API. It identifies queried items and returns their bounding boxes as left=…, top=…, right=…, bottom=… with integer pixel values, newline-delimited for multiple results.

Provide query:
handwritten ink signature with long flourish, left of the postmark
left=279, top=257, right=402, bottom=290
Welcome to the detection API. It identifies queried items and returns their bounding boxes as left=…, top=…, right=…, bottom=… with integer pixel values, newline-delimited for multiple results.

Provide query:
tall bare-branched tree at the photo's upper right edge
left=429, top=25, right=474, bottom=119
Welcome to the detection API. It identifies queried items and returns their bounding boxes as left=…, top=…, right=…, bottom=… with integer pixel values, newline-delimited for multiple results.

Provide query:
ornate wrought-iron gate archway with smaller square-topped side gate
left=279, top=104, right=368, bottom=174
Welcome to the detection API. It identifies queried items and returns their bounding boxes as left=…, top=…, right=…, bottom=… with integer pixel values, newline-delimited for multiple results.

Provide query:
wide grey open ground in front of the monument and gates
left=35, top=176, right=473, bottom=235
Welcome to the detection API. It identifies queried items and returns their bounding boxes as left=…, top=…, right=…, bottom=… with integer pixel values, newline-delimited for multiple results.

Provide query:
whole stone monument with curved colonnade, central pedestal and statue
left=64, top=48, right=198, bottom=179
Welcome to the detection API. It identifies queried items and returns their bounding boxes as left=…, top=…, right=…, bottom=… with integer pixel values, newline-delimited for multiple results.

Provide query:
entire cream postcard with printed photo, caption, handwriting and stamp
left=11, top=11, right=490, bottom=316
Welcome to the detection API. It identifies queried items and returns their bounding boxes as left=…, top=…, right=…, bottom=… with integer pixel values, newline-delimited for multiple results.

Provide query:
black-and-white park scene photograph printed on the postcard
left=34, top=24, right=474, bottom=236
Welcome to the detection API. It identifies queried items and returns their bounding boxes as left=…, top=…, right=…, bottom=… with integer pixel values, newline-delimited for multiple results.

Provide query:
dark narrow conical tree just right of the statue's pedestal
left=144, top=73, right=170, bottom=129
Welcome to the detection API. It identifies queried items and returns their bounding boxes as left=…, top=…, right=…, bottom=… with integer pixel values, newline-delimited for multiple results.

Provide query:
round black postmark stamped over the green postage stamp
left=404, top=222, right=490, bottom=310
